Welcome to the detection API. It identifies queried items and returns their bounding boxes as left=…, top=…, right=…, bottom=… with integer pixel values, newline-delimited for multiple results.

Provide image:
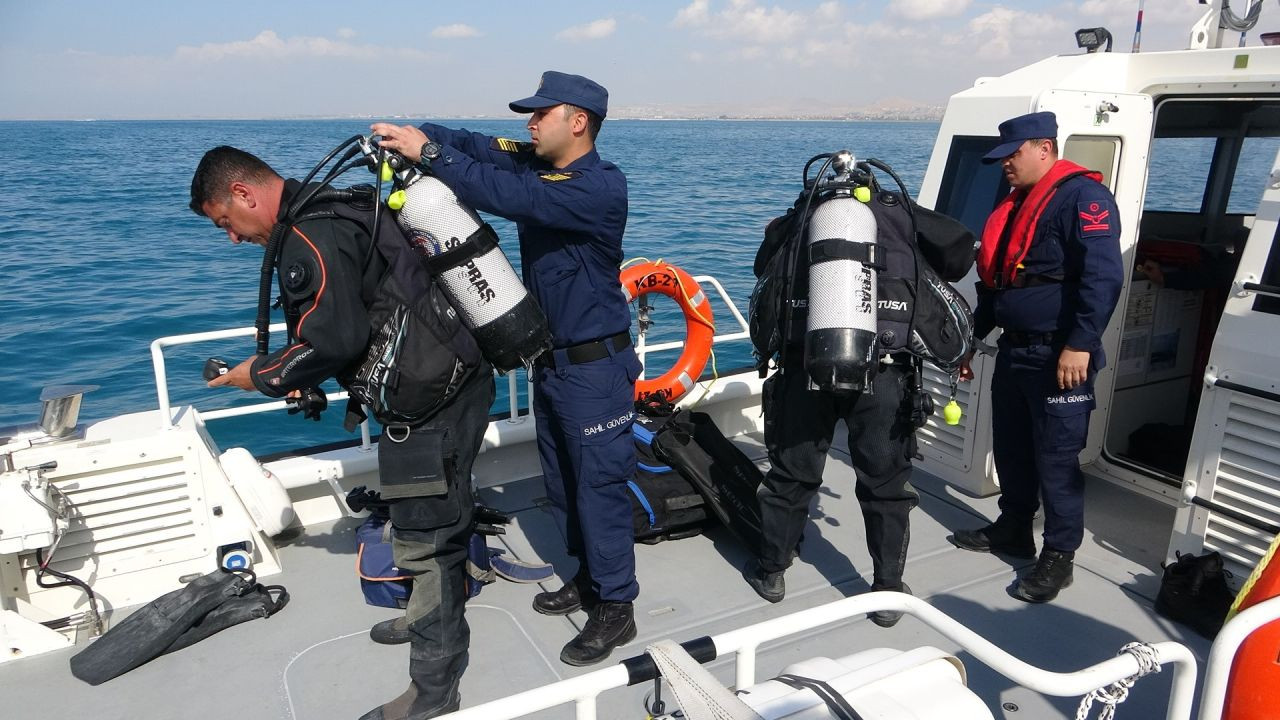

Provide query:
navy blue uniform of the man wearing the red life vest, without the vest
left=974, top=177, right=1124, bottom=552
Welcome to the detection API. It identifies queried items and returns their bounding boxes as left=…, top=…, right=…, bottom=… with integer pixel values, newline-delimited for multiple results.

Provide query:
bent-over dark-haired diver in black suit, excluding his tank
left=191, top=146, right=494, bottom=717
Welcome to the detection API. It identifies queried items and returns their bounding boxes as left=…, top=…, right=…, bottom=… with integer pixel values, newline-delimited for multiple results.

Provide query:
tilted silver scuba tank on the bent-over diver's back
left=397, top=170, right=552, bottom=373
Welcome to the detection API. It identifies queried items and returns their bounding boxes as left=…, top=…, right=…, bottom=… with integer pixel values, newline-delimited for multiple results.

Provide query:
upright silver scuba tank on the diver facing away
left=804, top=152, right=877, bottom=392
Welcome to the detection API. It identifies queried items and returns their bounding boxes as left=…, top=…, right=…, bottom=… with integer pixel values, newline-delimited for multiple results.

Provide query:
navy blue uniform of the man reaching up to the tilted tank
left=421, top=123, right=640, bottom=602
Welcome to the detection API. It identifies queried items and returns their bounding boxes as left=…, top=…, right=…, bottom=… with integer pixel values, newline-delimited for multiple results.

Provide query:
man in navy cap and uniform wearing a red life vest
left=947, top=113, right=1124, bottom=602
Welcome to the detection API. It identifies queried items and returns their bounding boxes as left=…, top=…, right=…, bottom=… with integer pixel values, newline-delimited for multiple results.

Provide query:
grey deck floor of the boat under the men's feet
left=0, top=430, right=1210, bottom=720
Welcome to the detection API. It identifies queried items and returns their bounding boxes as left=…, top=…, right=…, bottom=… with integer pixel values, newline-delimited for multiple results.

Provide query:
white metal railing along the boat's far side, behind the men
left=151, top=275, right=750, bottom=430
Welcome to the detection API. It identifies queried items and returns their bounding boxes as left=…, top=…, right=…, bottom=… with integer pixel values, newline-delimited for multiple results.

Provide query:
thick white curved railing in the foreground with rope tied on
left=442, top=592, right=1198, bottom=720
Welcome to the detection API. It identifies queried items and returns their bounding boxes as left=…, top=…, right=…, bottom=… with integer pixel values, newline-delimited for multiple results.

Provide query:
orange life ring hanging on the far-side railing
left=618, top=263, right=716, bottom=402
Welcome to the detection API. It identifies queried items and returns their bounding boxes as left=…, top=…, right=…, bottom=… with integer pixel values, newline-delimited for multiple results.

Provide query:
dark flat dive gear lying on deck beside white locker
left=70, top=569, right=289, bottom=685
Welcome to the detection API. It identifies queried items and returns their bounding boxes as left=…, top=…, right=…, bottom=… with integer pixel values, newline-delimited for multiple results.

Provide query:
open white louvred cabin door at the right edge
left=1169, top=148, right=1280, bottom=582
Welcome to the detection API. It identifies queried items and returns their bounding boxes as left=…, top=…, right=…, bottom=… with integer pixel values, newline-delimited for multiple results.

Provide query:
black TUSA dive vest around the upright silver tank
left=749, top=158, right=974, bottom=377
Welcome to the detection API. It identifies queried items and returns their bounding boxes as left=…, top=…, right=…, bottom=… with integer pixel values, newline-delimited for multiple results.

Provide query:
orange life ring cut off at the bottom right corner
left=1222, top=536, right=1280, bottom=720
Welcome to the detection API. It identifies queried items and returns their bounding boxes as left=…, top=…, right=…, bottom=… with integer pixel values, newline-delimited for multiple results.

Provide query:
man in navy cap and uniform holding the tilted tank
left=372, top=70, right=640, bottom=665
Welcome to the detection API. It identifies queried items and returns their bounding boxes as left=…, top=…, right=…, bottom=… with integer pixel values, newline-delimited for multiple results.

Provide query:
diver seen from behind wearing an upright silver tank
left=742, top=152, right=973, bottom=628
